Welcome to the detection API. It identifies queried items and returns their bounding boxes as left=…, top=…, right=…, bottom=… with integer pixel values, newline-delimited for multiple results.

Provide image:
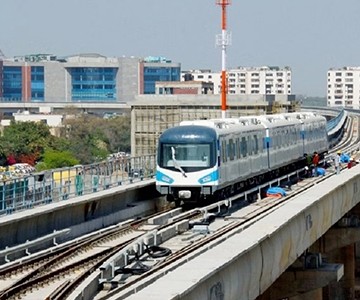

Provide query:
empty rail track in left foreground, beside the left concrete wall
left=0, top=207, right=202, bottom=300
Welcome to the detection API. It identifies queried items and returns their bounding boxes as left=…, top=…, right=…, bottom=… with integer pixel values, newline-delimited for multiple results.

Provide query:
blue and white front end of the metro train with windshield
left=156, top=125, right=219, bottom=203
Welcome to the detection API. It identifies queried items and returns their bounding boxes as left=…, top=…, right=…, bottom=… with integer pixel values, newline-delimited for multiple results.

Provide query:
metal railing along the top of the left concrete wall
left=0, top=155, right=156, bottom=215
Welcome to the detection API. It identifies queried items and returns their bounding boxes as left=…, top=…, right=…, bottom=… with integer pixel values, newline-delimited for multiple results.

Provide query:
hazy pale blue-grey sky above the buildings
left=0, top=0, right=360, bottom=96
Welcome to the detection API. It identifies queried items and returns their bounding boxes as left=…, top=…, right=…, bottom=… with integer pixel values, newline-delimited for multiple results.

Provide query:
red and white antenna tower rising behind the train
left=216, top=0, right=231, bottom=118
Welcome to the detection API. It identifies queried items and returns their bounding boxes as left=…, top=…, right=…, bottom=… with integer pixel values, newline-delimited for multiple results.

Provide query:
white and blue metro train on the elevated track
left=156, top=112, right=329, bottom=204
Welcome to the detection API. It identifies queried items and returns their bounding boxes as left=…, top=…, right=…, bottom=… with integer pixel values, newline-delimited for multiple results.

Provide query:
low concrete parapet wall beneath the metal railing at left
left=0, top=181, right=159, bottom=249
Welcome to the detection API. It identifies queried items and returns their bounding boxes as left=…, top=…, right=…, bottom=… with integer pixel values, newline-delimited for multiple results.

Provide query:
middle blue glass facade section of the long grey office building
left=69, top=67, right=117, bottom=101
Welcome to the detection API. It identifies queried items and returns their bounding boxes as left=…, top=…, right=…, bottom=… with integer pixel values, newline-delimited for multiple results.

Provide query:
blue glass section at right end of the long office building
left=144, top=64, right=181, bottom=94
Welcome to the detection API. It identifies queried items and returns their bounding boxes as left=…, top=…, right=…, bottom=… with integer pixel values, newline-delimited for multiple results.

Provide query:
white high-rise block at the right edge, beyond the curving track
left=327, top=67, right=360, bottom=109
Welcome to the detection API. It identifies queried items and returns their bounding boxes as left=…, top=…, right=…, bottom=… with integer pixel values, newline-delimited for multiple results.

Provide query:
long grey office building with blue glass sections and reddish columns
left=0, top=54, right=180, bottom=103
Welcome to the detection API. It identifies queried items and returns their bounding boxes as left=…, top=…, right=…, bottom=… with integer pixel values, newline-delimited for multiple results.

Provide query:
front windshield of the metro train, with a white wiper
left=159, top=144, right=215, bottom=172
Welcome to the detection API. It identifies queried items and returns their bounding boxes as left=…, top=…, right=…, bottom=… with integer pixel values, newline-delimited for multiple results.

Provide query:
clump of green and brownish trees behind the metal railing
left=0, top=114, right=130, bottom=169
